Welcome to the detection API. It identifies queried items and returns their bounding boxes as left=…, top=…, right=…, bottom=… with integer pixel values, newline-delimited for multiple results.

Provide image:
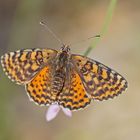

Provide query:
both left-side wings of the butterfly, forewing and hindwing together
left=1, top=49, right=57, bottom=105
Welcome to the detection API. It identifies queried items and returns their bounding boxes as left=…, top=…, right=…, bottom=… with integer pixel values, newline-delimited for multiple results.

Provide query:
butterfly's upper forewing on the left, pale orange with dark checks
left=1, top=49, right=57, bottom=84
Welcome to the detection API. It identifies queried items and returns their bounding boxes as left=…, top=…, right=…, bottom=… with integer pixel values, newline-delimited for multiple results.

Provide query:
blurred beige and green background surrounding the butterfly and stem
left=0, top=0, right=140, bottom=140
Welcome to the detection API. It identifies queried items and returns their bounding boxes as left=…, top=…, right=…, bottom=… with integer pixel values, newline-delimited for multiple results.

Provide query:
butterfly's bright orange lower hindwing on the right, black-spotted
left=58, top=66, right=91, bottom=110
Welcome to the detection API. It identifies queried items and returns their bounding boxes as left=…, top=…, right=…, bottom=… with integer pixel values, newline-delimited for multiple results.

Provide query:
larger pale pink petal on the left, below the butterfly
left=46, top=104, right=60, bottom=121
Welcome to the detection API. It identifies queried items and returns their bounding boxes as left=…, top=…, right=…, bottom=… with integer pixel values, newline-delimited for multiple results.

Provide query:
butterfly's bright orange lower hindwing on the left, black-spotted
left=26, top=65, right=52, bottom=105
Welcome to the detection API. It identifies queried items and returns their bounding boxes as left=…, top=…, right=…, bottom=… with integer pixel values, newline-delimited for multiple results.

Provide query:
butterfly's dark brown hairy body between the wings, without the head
left=52, top=46, right=70, bottom=99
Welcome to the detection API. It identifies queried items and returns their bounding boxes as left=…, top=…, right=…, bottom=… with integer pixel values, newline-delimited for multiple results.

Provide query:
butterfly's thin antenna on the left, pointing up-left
left=39, top=21, right=64, bottom=45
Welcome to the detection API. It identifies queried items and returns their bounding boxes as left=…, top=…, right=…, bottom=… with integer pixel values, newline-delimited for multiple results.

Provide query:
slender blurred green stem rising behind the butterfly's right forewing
left=84, top=0, right=117, bottom=56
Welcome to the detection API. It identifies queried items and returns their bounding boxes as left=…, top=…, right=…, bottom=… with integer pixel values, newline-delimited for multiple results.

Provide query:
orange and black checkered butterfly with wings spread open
left=1, top=45, right=128, bottom=110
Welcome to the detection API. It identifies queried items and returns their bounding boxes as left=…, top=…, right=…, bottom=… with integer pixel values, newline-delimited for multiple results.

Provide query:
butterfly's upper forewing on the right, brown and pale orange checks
left=71, top=55, right=127, bottom=100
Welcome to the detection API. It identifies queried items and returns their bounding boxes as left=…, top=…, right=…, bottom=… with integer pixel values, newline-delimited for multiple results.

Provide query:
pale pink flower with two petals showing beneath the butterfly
left=46, top=104, right=72, bottom=121
